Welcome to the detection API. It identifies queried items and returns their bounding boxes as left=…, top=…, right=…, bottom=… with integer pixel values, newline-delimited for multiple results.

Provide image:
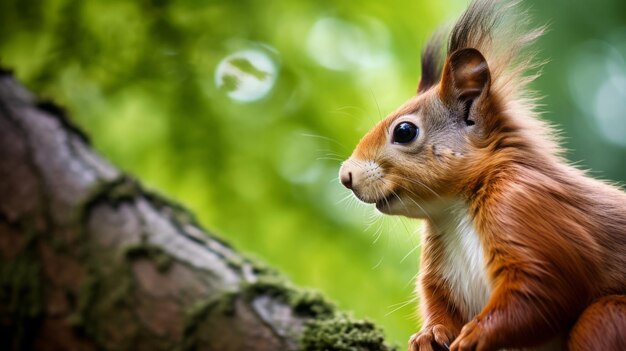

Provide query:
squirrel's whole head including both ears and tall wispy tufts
left=339, top=0, right=561, bottom=218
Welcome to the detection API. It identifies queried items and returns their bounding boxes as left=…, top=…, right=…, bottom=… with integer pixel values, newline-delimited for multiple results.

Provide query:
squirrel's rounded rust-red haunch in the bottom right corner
left=567, top=295, right=626, bottom=351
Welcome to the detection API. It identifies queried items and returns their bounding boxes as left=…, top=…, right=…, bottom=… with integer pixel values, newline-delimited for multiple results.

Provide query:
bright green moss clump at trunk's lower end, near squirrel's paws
left=300, top=315, right=396, bottom=351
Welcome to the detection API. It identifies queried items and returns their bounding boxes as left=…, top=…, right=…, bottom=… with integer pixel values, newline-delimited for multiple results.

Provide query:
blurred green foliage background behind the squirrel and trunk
left=0, top=0, right=626, bottom=344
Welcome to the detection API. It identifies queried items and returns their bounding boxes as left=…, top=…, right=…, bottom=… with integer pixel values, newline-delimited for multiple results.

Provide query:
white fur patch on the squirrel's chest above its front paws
left=433, top=205, right=491, bottom=321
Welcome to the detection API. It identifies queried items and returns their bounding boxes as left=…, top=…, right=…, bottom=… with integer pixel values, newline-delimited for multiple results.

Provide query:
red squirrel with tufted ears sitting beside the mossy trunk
left=339, top=0, right=626, bottom=351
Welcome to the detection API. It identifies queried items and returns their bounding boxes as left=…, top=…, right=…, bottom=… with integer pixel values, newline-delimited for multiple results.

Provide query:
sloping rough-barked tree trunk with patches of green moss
left=0, top=70, right=389, bottom=350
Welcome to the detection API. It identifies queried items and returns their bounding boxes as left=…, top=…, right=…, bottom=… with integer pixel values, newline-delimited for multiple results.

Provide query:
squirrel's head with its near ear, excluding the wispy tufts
left=339, top=48, right=491, bottom=218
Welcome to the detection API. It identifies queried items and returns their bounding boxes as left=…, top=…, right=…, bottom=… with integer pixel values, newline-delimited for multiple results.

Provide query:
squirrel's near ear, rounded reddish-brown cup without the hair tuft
left=441, top=48, right=491, bottom=102
